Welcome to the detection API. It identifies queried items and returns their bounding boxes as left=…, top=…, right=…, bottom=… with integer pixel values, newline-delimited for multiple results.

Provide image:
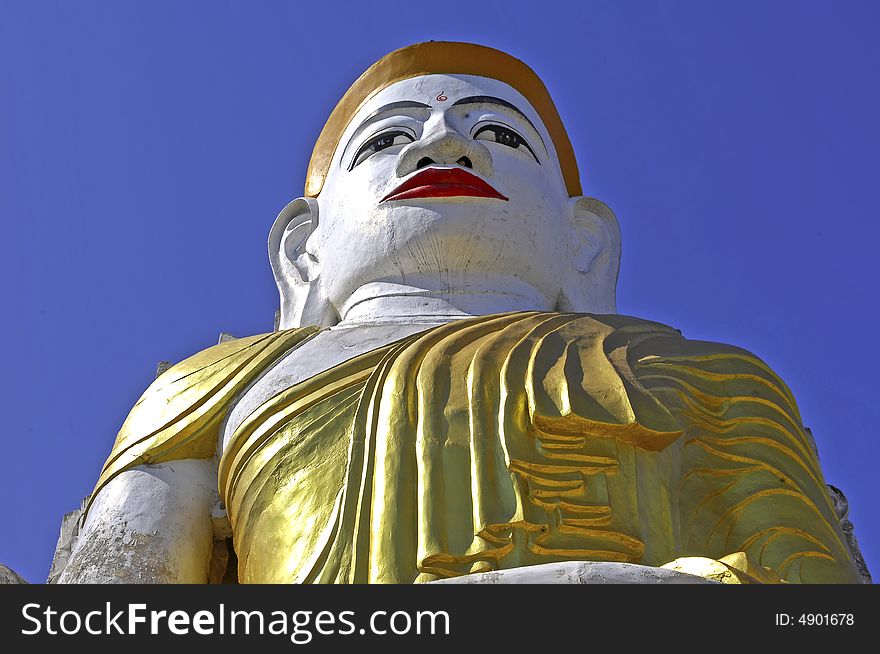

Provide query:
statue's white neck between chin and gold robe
left=339, top=279, right=553, bottom=327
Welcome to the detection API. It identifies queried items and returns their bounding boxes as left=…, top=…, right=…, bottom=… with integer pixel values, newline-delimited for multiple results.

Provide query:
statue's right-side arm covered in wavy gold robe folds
left=636, top=339, right=859, bottom=583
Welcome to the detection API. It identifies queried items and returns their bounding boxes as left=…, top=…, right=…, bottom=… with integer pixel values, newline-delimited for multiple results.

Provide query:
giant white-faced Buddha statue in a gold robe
left=62, top=42, right=859, bottom=583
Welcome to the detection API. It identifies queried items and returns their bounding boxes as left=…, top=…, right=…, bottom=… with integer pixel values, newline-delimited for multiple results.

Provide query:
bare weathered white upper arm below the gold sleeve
left=59, top=459, right=217, bottom=583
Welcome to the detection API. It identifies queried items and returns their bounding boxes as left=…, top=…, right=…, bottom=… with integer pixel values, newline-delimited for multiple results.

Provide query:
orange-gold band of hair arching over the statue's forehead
left=305, top=41, right=581, bottom=197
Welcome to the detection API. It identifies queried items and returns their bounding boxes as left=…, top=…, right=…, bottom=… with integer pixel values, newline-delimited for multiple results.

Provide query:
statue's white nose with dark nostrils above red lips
left=395, top=121, right=492, bottom=177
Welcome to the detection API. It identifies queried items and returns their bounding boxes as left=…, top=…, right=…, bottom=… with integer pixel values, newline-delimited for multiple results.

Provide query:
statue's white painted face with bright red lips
left=306, top=75, right=571, bottom=310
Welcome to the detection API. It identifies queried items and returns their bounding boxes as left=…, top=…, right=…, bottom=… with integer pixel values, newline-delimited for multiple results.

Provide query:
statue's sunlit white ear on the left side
left=269, top=198, right=337, bottom=329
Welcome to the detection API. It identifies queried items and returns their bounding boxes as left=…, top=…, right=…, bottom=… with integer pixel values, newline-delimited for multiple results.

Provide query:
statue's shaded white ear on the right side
left=557, top=197, right=620, bottom=313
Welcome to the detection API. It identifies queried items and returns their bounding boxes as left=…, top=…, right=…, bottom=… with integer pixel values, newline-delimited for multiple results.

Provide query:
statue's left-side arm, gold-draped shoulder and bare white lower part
left=60, top=329, right=314, bottom=583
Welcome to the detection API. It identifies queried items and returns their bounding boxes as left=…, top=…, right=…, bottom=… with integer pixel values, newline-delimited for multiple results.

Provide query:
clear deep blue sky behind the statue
left=0, top=0, right=880, bottom=581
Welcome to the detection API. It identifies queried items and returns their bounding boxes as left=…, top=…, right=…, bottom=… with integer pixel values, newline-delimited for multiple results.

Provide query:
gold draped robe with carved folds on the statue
left=87, top=312, right=858, bottom=583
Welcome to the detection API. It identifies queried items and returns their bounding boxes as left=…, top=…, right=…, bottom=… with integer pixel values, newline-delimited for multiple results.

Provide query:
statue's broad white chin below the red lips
left=318, top=204, right=562, bottom=301
